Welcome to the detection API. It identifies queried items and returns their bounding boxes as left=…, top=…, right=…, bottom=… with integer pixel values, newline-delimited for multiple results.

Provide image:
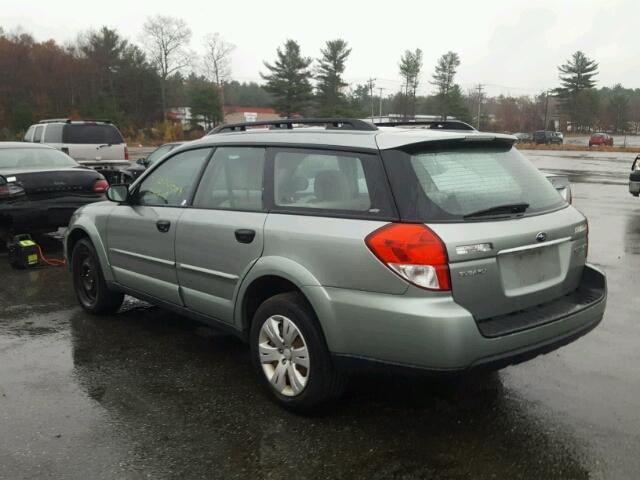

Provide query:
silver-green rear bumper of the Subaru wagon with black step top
left=305, top=266, right=607, bottom=373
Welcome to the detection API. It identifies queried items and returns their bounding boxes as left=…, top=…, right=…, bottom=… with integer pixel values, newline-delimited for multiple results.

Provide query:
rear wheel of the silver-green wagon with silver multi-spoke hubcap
left=250, top=292, right=345, bottom=413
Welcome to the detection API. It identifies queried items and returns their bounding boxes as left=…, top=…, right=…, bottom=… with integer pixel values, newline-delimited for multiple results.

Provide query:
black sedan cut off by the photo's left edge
left=0, top=142, right=109, bottom=237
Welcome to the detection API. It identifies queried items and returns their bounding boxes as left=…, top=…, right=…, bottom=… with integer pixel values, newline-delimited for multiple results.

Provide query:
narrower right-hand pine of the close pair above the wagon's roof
left=316, top=38, right=351, bottom=116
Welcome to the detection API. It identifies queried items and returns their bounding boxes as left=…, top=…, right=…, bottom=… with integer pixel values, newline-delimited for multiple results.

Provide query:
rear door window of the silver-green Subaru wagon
left=193, top=147, right=265, bottom=211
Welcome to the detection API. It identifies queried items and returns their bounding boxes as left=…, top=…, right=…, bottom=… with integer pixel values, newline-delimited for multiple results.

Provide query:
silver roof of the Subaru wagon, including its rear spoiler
left=187, top=127, right=516, bottom=150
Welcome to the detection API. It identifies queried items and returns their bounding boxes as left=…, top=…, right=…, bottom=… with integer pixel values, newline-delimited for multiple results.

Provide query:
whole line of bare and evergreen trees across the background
left=0, top=16, right=640, bottom=139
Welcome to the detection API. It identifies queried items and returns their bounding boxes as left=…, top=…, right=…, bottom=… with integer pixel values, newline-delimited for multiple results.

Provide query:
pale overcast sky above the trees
left=0, top=0, right=640, bottom=95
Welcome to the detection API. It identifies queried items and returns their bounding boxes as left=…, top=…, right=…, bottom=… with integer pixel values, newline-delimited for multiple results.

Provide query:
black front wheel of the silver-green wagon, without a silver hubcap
left=71, top=238, right=124, bottom=315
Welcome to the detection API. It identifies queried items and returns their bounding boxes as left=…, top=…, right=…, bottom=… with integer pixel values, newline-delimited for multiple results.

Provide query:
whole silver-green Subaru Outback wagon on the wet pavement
left=65, top=119, right=607, bottom=411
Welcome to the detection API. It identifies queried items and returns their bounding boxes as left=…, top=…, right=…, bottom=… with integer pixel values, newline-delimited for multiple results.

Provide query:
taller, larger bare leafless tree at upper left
left=142, top=15, right=192, bottom=118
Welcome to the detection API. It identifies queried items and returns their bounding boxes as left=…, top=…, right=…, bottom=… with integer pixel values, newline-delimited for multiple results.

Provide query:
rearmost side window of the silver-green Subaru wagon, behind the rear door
left=272, top=149, right=393, bottom=217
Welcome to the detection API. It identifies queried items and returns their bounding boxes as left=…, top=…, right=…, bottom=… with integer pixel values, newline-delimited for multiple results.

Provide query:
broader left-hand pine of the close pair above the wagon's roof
left=260, top=40, right=312, bottom=118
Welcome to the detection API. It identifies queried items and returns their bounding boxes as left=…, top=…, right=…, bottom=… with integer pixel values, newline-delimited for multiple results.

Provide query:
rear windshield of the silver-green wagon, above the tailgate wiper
left=383, top=144, right=565, bottom=222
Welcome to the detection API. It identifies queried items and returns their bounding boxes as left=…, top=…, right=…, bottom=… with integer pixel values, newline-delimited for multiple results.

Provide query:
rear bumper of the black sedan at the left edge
left=0, top=195, right=105, bottom=233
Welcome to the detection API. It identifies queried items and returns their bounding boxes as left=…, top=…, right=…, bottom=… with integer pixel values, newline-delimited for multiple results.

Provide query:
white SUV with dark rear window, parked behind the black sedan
left=24, top=118, right=129, bottom=161
